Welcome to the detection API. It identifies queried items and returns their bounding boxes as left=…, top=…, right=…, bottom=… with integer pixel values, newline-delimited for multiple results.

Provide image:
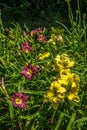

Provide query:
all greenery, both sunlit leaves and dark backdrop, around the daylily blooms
left=0, top=0, right=87, bottom=130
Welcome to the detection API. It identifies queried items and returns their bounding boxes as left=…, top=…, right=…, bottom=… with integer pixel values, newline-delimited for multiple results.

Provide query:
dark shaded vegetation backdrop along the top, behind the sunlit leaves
left=0, top=0, right=87, bottom=28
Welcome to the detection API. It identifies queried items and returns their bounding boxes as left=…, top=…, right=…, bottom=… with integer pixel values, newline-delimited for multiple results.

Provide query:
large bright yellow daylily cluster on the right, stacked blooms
left=44, top=54, right=80, bottom=109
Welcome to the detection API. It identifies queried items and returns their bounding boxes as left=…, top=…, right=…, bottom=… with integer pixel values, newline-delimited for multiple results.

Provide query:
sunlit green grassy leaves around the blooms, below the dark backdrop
left=0, top=0, right=87, bottom=130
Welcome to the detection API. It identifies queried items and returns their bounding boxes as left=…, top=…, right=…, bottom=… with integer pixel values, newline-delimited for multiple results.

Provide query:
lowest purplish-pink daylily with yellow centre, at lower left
left=10, top=92, right=29, bottom=109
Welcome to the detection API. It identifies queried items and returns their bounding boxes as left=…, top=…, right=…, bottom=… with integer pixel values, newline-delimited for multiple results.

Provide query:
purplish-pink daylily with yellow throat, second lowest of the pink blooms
left=20, top=63, right=37, bottom=80
